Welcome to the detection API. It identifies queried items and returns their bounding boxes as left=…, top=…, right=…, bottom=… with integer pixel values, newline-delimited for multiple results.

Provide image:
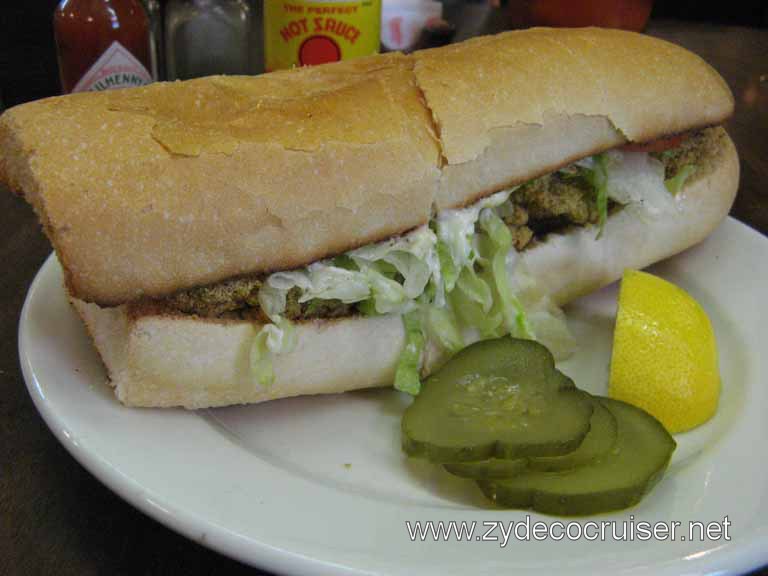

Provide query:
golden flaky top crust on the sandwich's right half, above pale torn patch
left=414, top=28, right=734, bottom=164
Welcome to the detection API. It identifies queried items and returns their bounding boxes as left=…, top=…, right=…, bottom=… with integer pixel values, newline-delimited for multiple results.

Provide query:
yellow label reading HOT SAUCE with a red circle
left=264, top=0, right=381, bottom=71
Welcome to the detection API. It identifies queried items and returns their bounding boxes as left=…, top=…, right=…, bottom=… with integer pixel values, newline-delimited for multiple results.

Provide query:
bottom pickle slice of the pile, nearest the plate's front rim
left=477, top=399, right=675, bottom=516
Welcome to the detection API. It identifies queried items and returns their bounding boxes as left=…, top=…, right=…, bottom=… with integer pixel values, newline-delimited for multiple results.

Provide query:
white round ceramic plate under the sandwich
left=19, top=219, right=768, bottom=575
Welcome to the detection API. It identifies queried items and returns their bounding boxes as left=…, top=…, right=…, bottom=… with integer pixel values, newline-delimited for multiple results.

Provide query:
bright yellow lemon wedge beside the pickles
left=608, top=270, right=720, bottom=433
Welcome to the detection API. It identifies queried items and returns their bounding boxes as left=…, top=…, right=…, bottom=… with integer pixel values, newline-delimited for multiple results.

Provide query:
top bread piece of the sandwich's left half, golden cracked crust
left=0, top=54, right=439, bottom=304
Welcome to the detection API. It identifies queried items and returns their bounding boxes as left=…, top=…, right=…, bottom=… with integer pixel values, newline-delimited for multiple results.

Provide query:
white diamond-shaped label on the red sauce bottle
left=72, top=41, right=152, bottom=92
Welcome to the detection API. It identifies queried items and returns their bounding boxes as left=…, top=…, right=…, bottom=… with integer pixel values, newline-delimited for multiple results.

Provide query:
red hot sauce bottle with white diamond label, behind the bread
left=53, top=0, right=153, bottom=93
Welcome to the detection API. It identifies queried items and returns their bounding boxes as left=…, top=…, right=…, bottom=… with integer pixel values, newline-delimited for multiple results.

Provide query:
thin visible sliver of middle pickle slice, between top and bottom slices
left=443, top=393, right=617, bottom=480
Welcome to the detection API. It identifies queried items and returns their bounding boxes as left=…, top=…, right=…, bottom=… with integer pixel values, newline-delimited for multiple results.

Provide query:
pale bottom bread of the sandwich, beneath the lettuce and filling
left=73, top=138, right=739, bottom=408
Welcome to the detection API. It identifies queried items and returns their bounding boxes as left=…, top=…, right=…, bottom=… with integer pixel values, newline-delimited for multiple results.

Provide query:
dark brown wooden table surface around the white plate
left=0, top=22, right=768, bottom=576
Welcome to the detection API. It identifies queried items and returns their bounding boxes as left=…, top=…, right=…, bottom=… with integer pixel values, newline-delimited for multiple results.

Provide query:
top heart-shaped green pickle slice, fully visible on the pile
left=402, top=337, right=592, bottom=463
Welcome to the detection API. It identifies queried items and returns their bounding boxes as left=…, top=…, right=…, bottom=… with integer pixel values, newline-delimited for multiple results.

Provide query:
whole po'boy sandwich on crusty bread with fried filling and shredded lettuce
left=0, top=29, right=739, bottom=408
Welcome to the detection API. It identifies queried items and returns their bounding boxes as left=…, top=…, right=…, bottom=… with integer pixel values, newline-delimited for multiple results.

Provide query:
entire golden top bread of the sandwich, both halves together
left=0, top=29, right=733, bottom=305
